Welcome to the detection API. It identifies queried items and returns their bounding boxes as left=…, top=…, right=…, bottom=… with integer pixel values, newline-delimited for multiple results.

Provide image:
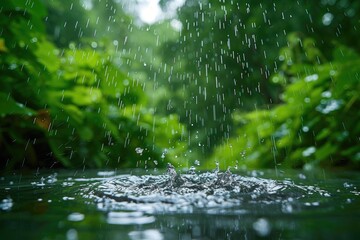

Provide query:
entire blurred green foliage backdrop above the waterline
left=0, top=0, right=360, bottom=172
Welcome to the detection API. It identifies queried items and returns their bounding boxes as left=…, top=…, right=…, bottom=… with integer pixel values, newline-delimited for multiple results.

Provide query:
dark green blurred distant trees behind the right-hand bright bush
left=159, top=0, right=360, bottom=156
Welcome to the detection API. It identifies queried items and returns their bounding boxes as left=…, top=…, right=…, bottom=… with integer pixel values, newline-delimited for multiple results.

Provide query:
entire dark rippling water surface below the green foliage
left=0, top=168, right=360, bottom=240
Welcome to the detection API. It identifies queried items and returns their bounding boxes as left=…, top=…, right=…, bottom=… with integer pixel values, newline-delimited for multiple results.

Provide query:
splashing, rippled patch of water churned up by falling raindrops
left=84, top=164, right=330, bottom=214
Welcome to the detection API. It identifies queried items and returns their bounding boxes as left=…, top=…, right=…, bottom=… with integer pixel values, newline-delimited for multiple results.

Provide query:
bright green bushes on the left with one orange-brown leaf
left=0, top=0, right=186, bottom=169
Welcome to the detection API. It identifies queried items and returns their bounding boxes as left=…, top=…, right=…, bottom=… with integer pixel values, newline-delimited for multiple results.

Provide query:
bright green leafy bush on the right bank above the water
left=213, top=35, right=360, bottom=168
